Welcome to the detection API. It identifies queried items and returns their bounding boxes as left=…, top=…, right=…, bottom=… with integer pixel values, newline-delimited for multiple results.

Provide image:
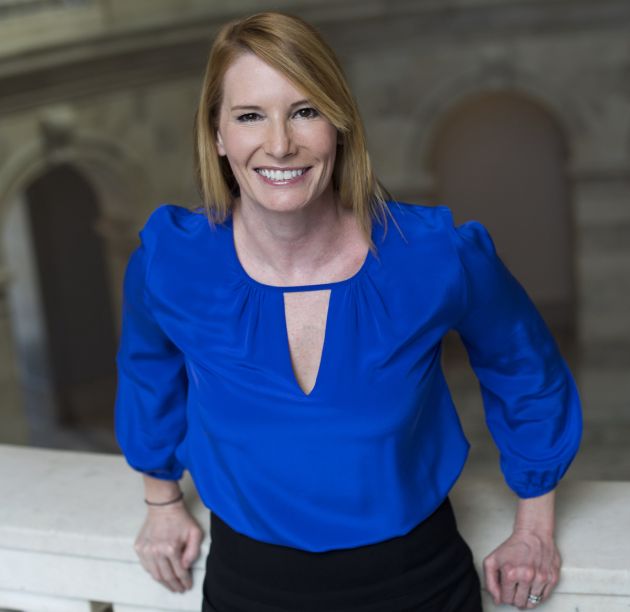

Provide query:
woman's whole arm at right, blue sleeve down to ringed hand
left=454, top=216, right=582, bottom=608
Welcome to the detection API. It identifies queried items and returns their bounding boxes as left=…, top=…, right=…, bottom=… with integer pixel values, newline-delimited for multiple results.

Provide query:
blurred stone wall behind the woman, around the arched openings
left=0, top=0, right=630, bottom=460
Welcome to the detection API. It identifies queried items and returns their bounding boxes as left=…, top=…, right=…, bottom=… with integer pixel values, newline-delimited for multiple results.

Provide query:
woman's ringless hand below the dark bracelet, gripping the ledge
left=134, top=501, right=203, bottom=593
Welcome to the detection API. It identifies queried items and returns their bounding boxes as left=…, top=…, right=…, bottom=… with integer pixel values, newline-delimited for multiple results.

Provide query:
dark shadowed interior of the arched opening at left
left=25, top=164, right=116, bottom=428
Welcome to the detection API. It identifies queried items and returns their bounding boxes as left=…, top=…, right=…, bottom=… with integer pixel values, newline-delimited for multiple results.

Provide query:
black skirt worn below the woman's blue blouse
left=202, top=499, right=482, bottom=612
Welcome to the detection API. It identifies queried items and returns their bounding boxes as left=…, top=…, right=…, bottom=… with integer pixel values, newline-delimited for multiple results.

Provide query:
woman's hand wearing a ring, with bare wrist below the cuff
left=483, top=491, right=561, bottom=610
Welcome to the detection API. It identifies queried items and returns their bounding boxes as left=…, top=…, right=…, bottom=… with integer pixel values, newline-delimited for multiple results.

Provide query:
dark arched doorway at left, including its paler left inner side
left=7, top=164, right=116, bottom=445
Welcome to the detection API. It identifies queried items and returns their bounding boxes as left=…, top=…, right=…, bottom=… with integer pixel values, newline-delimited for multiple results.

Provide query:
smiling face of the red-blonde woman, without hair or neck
left=217, top=53, right=337, bottom=218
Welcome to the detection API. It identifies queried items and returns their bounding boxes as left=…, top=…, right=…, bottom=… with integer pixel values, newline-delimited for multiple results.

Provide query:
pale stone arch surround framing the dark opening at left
left=0, top=109, right=147, bottom=445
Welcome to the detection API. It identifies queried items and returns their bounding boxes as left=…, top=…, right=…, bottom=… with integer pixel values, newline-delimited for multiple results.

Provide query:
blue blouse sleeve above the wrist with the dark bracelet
left=115, top=228, right=188, bottom=480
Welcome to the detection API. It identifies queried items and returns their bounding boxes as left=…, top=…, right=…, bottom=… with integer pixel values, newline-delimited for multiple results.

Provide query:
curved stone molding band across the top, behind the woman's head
left=0, top=0, right=630, bottom=113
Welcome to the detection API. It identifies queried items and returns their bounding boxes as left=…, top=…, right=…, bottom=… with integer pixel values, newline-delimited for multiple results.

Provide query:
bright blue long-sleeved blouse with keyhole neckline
left=116, top=202, right=581, bottom=551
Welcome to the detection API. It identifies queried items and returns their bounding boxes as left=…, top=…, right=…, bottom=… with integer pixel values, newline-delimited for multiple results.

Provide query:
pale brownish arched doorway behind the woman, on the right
left=431, top=92, right=576, bottom=343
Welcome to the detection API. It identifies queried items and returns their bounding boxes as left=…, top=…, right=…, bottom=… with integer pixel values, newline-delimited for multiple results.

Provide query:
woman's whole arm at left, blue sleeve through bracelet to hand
left=116, top=227, right=202, bottom=592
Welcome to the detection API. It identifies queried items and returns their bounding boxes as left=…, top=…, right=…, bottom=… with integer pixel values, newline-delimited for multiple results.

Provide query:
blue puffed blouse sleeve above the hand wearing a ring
left=454, top=221, right=582, bottom=498
